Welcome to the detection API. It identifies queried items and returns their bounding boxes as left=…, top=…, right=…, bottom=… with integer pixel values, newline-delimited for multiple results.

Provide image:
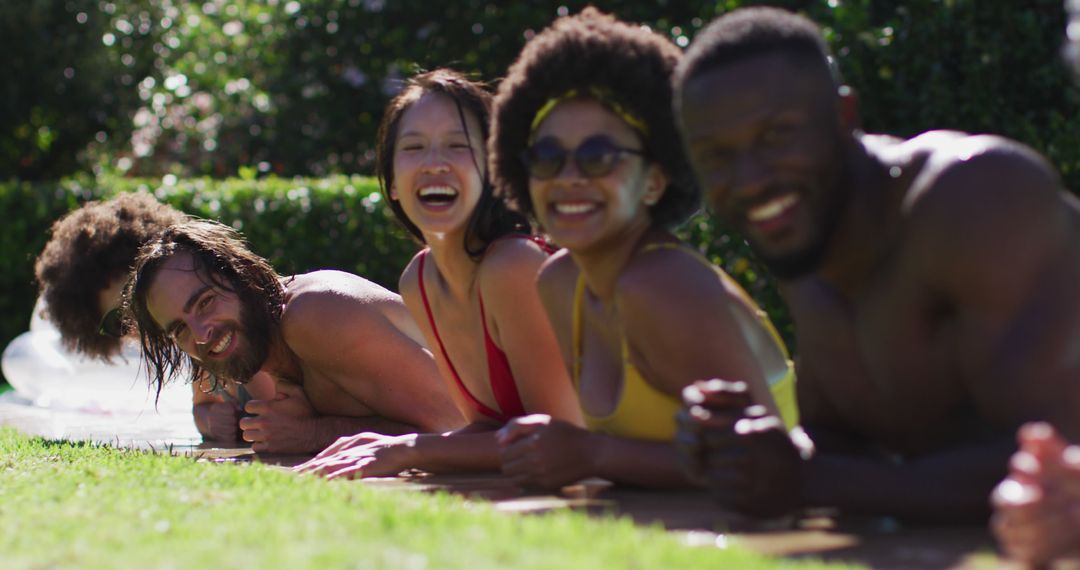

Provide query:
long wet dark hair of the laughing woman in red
left=375, top=69, right=531, bottom=258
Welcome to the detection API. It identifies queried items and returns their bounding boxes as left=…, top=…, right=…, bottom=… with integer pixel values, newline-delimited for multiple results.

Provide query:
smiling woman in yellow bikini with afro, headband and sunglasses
left=490, top=9, right=795, bottom=487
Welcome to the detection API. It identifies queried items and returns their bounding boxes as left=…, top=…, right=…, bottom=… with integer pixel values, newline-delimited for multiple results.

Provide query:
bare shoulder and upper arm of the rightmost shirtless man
left=910, top=137, right=1080, bottom=437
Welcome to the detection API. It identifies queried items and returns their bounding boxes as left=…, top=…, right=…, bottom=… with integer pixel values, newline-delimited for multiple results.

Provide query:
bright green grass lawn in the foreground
left=0, top=429, right=851, bottom=569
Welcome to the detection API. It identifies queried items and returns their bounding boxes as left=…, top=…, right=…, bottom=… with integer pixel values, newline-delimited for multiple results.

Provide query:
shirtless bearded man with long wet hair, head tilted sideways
left=125, top=219, right=461, bottom=453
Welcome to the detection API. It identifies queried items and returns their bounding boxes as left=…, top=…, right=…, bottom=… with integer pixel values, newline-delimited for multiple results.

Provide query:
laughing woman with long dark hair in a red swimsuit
left=298, top=69, right=581, bottom=477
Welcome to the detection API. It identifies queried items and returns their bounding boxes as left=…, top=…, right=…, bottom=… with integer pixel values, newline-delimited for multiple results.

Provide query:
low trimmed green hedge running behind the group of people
left=0, top=176, right=792, bottom=384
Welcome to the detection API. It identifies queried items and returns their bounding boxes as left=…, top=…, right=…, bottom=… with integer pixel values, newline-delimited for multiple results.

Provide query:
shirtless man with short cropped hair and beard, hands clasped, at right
left=677, top=9, right=1080, bottom=521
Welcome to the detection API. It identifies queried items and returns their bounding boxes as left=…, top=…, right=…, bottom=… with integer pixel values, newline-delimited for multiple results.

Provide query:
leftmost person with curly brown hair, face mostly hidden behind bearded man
left=23, top=192, right=273, bottom=442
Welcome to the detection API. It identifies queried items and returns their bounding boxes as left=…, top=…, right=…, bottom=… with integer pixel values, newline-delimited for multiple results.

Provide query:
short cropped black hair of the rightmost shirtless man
left=674, top=6, right=840, bottom=107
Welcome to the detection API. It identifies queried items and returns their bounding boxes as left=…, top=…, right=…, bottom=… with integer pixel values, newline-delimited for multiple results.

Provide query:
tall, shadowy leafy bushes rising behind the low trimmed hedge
left=6, top=0, right=1080, bottom=188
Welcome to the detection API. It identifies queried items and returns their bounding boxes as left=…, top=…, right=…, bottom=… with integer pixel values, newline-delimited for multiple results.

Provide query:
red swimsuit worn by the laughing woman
left=412, top=235, right=551, bottom=423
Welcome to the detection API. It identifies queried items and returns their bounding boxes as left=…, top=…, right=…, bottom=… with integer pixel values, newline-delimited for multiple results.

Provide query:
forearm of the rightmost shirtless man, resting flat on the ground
left=802, top=440, right=1015, bottom=523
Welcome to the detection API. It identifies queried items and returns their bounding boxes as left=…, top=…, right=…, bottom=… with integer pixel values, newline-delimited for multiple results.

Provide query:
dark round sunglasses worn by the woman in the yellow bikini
left=522, top=135, right=645, bottom=180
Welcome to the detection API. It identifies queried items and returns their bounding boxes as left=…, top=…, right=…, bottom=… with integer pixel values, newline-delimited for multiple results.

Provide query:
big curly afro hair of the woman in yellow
left=488, top=8, right=701, bottom=228
